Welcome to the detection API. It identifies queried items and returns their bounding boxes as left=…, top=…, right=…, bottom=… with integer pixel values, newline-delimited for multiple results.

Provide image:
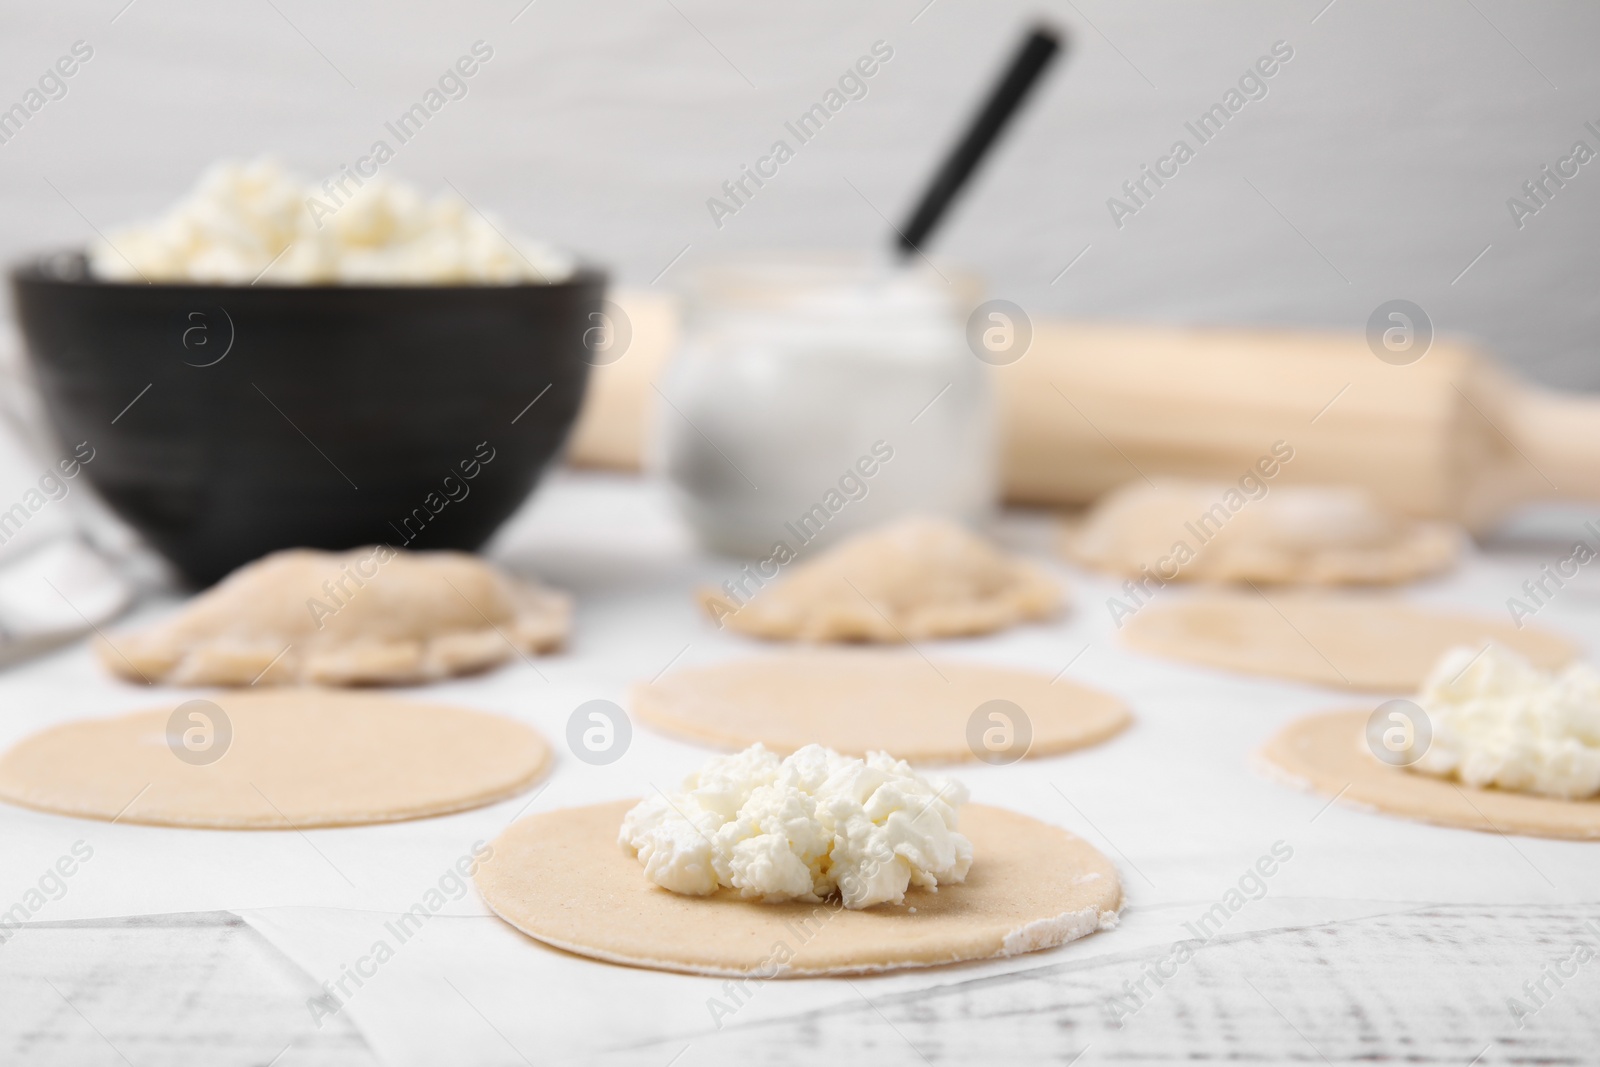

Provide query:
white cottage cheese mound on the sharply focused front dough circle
left=619, top=744, right=973, bottom=909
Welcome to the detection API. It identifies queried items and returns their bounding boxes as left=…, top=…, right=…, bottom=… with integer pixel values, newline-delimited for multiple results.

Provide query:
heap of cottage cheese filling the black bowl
left=90, top=158, right=573, bottom=285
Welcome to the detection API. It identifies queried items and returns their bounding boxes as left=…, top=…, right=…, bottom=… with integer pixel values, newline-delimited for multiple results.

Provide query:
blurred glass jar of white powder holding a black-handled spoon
left=653, top=256, right=997, bottom=561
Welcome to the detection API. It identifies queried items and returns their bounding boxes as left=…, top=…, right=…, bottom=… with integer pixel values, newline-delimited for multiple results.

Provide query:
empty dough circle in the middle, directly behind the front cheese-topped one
left=634, top=651, right=1133, bottom=763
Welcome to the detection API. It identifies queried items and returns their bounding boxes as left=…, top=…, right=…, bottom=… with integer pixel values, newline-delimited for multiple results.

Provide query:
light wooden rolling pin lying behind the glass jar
left=568, top=293, right=1600, bottom=528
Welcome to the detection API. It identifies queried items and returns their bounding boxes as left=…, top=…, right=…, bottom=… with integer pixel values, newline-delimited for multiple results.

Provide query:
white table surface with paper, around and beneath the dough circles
left=0, top=474, right=1600, bottom=1067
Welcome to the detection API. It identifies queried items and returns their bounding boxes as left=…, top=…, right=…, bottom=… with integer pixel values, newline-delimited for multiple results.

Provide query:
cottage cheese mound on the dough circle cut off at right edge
left=1410, top=645, right=1600, bottom=800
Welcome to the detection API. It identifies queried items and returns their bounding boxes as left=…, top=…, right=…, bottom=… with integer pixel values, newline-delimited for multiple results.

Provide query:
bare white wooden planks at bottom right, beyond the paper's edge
left=635, top=905, right=1600, bottom=1067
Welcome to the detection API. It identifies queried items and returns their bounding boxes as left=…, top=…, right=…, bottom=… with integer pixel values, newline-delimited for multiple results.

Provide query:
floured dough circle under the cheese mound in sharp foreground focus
left=477, top=800, right=1122, bottom=977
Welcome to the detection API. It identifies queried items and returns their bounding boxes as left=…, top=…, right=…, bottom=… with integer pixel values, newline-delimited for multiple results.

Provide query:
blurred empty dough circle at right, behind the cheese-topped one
left=1123, top=593, right=1578, bottom=693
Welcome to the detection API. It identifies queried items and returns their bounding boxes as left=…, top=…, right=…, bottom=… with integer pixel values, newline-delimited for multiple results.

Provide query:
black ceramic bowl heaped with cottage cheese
left=11, top=253, right=605, bottom=585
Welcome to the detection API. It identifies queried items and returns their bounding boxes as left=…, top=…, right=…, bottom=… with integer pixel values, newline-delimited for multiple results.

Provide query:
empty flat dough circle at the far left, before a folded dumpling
left=0, top=689, right=550, bottom=830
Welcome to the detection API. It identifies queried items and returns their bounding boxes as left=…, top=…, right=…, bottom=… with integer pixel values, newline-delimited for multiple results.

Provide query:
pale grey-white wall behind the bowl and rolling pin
left=0, top=0, right=1600, bottom=389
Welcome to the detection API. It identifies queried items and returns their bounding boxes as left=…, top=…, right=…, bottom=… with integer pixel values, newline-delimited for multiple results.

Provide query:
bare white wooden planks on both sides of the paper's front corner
left=0, top=905, right=1600, bottom=1067
